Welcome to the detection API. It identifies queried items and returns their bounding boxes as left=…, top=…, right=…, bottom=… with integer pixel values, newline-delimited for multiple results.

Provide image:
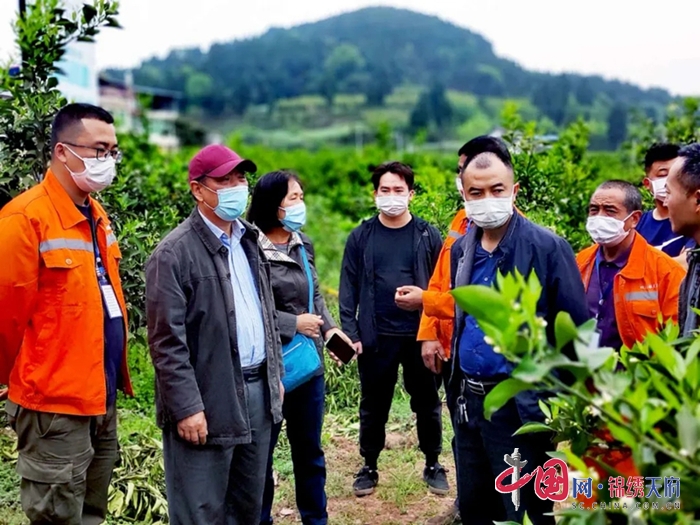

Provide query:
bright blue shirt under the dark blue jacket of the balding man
left=459, top=242, right=512, bottom=379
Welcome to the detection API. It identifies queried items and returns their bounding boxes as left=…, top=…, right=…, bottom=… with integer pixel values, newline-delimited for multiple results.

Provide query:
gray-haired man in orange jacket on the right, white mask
left=576, top=180, right=685, bottom=350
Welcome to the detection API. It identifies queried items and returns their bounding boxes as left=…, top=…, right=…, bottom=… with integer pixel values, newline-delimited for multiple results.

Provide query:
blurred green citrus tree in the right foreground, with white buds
left=453, top=273, right=700, bottom=525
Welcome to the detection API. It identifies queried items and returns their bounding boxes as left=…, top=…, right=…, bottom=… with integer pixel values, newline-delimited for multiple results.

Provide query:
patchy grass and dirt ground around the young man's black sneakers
left=273, top=393, right=456, bottom=525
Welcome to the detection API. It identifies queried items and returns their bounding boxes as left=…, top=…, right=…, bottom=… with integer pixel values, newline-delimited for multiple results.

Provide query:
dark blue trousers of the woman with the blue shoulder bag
left=260, top=375, right=328, bottom=525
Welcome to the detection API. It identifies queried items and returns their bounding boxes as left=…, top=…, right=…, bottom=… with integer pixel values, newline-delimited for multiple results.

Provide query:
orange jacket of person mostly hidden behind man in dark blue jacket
left=418, top=209, right=468, bottom=357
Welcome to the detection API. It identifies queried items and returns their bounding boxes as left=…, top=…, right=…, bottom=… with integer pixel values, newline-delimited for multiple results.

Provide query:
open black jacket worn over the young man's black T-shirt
left=340, top=215, right=442, bottom=348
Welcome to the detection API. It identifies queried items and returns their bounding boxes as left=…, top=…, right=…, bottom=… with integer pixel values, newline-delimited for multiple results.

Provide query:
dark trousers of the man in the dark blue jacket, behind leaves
left=453, top=382, right=556, bottom=525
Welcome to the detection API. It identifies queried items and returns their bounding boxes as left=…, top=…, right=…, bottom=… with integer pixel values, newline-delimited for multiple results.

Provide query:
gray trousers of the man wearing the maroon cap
left=163, top=378, right=272, bottom=525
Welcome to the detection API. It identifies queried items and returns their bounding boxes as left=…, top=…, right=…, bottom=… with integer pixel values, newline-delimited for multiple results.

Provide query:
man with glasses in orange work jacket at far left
left=0, top=104, right=132, bottom=524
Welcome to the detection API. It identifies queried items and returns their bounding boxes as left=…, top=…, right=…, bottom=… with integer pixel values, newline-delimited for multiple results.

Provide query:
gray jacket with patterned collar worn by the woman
left=259, top=232, right=336, bottom=363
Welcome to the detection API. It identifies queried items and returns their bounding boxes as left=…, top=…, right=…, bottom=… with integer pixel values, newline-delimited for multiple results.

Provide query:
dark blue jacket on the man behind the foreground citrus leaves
left=450, top=213, right=589, bottom=422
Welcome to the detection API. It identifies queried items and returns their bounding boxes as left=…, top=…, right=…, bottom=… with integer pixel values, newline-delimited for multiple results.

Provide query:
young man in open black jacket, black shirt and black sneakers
left=340, top=162, right=442, bottom=496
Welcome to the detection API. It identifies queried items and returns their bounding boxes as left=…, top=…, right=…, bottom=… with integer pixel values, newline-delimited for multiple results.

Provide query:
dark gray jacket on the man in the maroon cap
left=146, top=208, right=283, bottom=445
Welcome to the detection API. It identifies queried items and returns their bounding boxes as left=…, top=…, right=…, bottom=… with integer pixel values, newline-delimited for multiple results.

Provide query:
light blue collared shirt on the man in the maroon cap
left=199, top=211, right=265, bottom=368
